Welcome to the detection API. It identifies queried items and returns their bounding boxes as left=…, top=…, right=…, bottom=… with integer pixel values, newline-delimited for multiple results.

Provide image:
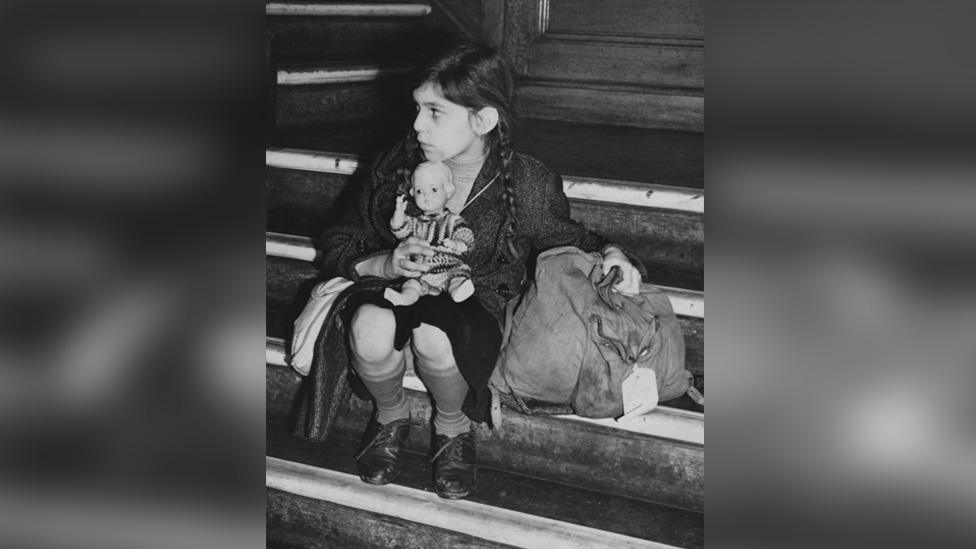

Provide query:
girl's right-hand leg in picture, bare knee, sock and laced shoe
left=412, top=324, right=476, bottom=499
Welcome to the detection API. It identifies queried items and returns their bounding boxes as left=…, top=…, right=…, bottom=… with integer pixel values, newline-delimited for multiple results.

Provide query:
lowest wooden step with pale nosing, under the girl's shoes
left=267, top=426, right=704, bottom=548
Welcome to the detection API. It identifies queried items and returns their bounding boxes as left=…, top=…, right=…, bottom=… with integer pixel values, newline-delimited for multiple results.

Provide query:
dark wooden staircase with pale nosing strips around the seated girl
left=266, top=0, right=704, bottom=548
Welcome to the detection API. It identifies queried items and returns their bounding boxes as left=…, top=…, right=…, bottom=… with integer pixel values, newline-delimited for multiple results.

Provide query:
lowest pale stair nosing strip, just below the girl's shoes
left=265, top=456, right=673, bottom=549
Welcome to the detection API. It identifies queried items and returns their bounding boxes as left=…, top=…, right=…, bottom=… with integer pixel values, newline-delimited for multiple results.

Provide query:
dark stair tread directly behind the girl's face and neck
left=272, top=115, right=705, bottom=189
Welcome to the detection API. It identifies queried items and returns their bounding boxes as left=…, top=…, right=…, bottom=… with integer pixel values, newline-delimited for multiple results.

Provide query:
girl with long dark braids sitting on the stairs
left=322, top=40, right=644, bottom=499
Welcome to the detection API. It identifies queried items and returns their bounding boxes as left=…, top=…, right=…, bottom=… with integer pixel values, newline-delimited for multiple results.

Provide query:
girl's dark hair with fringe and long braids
left=400, top=43, right=517, bottom=257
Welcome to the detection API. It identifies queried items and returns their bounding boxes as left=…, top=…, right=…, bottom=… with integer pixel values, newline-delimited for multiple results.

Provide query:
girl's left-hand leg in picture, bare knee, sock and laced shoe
left=349, top=305, right=410, bottom=484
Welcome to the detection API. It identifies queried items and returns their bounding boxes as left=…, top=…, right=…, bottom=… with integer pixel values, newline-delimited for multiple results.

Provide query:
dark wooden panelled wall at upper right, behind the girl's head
left=496, top=0, right=705, bottom=131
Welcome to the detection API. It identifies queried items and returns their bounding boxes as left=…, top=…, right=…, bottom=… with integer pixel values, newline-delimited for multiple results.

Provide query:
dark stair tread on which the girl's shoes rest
left=267, top=423, right=704, bottom=547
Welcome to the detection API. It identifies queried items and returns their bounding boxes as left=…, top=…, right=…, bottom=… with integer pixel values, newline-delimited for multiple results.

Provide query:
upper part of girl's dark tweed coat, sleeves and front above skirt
left=319, top=142, right=647, bottom=327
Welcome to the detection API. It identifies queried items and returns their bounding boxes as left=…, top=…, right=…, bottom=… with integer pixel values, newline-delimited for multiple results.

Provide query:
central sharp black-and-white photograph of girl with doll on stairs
left=265, top=0, right=705, bottom=548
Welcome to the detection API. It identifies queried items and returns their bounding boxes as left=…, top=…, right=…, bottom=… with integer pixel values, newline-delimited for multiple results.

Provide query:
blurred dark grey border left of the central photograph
left=0, top=0, right=265, bottom=548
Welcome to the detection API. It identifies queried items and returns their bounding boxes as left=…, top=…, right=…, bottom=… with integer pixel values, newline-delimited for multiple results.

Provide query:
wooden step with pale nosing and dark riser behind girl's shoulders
left=266, top=144, right=705, bottom=282
